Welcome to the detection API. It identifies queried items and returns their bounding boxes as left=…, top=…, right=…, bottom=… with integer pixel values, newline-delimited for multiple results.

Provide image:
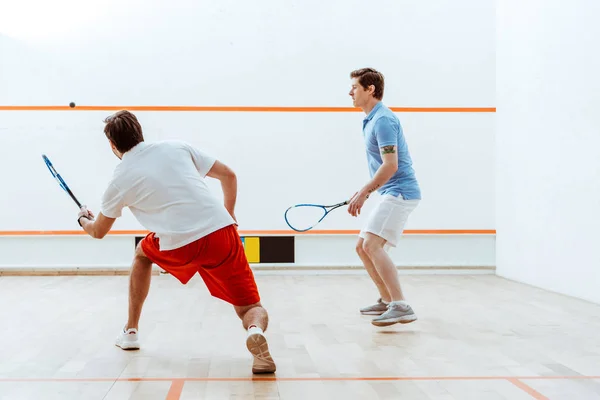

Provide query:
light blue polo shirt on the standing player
left=363, top=102, right=421, bottom=200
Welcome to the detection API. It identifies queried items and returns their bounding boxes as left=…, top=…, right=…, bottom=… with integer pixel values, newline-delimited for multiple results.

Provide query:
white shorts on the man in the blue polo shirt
left=358, top=194, right=420, bottom=247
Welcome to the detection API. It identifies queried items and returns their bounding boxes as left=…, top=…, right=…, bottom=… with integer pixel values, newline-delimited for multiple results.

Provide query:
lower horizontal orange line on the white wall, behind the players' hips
left=0, top=229, right=496, bottom=236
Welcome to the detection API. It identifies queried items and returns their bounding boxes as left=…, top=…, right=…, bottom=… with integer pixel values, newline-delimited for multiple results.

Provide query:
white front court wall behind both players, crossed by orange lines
left=0, top=0, right=495, bottom=266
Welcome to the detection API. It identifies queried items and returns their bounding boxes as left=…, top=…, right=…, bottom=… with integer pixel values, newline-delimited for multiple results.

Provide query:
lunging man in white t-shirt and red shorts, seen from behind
left=78, top=111, right=276, bottom=373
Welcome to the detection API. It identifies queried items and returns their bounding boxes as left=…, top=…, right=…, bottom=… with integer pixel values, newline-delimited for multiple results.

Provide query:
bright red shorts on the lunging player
left=140, top=225, right=260, bottom=306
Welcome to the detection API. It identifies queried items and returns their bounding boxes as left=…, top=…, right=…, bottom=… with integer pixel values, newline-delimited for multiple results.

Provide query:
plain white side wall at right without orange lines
left=496, top=0, right=600, bottom=303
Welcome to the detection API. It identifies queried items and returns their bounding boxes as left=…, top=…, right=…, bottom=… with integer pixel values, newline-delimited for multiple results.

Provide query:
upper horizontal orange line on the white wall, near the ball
left=0, top=105, right=496, bottom=113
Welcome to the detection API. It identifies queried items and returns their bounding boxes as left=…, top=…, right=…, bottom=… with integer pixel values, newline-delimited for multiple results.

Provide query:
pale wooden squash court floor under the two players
left=0, top=274, right=600, bottom=400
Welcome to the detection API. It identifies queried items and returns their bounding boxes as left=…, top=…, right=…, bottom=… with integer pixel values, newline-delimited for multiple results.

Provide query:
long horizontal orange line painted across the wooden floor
left=0, top=375, right=600, bottom=382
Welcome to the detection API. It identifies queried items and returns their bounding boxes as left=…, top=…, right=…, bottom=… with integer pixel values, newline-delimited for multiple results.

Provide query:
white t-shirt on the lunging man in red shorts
left=101, top=141, right=235, bottom=250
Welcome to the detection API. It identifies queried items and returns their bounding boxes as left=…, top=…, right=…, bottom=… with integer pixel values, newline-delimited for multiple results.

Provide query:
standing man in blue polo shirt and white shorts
left=348, top=68, right=421, bottom=326
